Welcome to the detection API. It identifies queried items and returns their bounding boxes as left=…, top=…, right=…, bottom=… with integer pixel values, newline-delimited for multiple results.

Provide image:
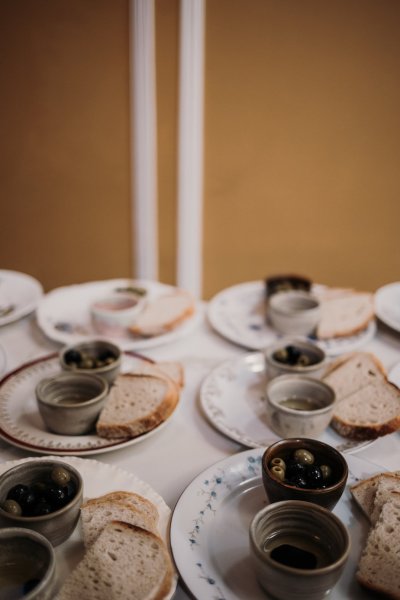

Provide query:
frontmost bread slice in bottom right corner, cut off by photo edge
left=356, top=494, right=400, bottom=600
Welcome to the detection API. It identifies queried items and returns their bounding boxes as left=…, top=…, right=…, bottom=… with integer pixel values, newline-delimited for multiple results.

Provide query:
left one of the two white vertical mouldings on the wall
left=130, top=0, right=158, bottom=280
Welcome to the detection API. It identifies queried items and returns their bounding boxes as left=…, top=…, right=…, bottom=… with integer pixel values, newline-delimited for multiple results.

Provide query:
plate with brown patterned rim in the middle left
left=0, top=354, right=178, bottom=456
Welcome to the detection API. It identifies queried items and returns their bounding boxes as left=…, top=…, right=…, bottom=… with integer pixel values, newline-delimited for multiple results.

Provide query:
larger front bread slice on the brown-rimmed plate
left=96, top=373, right=179, bottom=439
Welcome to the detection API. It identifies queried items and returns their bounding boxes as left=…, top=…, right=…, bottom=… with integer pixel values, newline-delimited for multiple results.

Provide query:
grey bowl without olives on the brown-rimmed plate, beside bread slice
left=35, top=372, right=109, bottom=435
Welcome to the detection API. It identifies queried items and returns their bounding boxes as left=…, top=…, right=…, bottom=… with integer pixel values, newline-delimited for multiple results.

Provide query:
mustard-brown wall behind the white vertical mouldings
left=0, top=0, right=400, bottom=297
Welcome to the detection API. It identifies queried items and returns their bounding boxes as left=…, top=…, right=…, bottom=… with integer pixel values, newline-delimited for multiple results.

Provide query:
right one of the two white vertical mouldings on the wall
left=177, top=0, right=205, bottom=298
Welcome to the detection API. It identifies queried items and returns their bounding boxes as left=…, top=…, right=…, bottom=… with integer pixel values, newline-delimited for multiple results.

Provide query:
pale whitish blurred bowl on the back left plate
left=90, top=292, right=146, bottom=336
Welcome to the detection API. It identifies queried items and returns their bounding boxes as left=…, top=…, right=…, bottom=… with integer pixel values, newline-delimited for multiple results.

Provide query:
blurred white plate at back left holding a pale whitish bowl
left=37, top=279, right=199, bottom=350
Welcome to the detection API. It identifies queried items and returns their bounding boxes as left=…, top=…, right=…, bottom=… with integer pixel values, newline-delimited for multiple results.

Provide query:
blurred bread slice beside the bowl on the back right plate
left=316, top=292, right=375, bottom=340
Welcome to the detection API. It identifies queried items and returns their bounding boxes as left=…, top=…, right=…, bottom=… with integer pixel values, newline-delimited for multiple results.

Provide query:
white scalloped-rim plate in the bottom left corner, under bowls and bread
left=0, top=456, right=177, bottom=599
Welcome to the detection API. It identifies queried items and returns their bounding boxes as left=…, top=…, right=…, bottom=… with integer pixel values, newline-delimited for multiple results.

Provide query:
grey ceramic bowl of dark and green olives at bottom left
left=0, top=460, right=83, bottom=546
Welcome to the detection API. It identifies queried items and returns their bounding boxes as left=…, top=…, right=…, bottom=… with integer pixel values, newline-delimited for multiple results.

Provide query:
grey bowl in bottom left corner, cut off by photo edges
left=0, top=527, right=56, bottom=600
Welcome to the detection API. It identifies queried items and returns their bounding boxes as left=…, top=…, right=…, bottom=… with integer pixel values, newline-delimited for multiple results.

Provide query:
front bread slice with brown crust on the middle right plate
left=331, top=379, right=400, bottom=440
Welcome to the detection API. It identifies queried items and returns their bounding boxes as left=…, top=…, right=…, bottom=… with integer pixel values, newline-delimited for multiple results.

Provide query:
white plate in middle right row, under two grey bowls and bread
left=200, top=352, right=374, bottom=452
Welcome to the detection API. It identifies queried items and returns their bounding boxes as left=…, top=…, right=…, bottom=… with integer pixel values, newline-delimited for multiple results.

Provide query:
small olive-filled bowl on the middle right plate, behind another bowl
left=264, top=337, right=327, bottom=379
